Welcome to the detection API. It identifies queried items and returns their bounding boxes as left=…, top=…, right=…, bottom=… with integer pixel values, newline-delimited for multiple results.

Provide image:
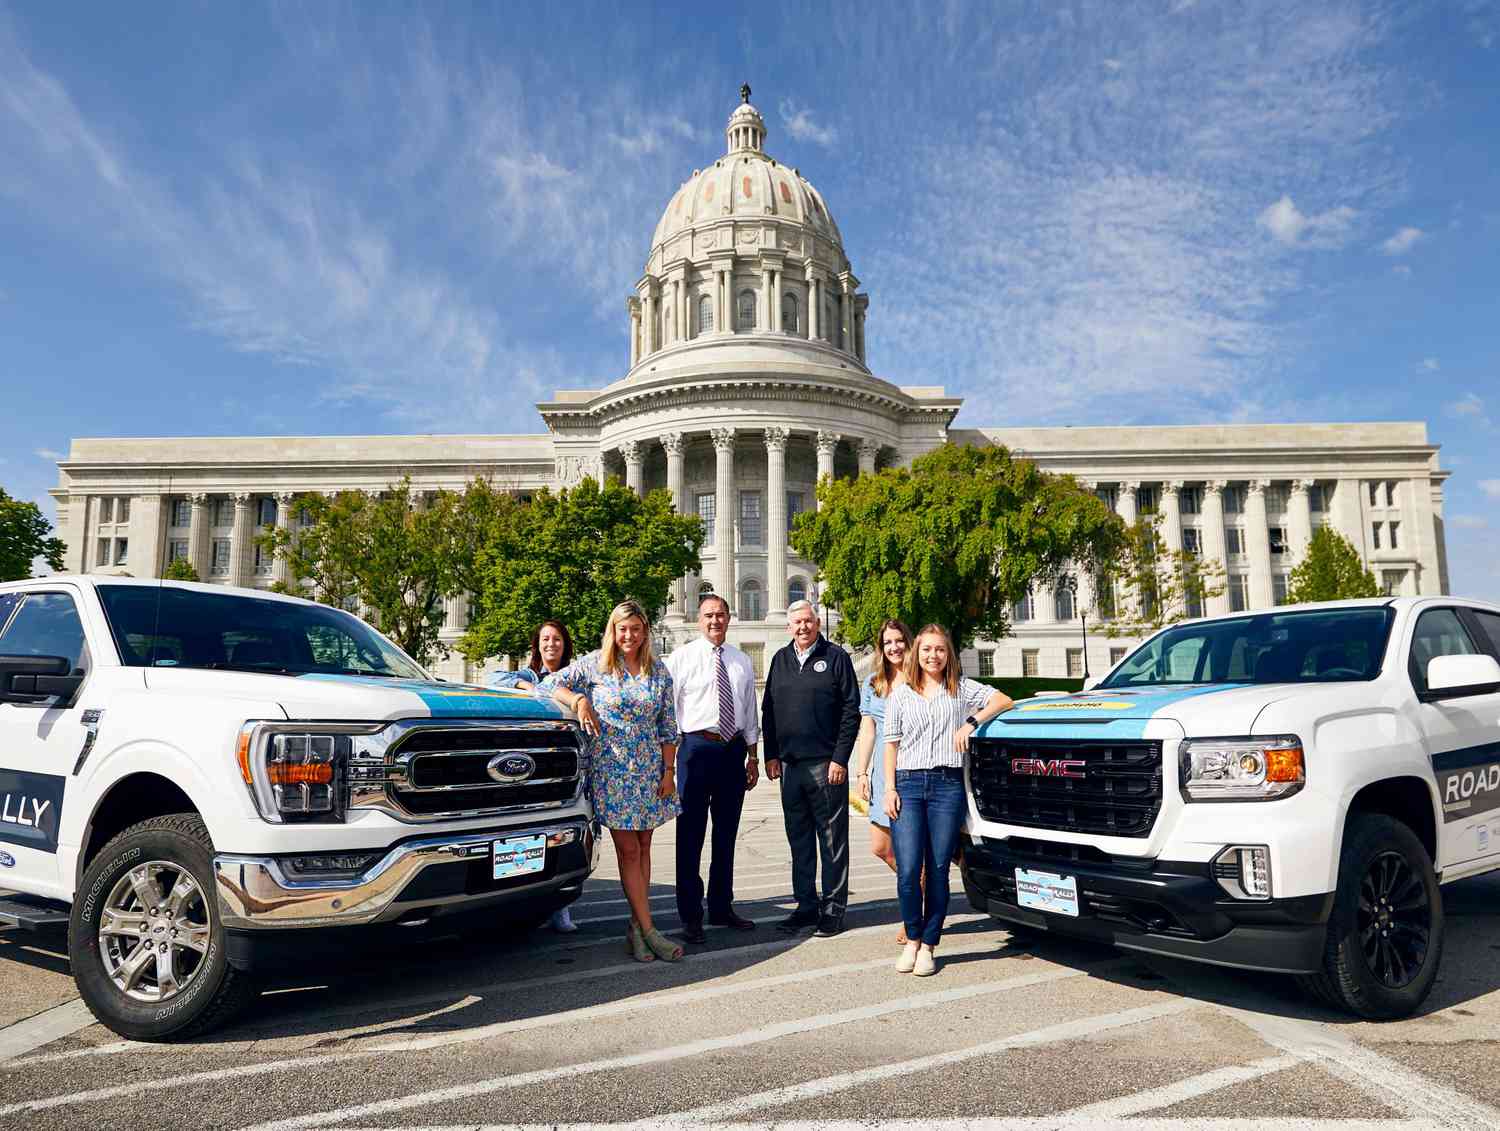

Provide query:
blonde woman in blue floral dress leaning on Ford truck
left=537, top=602, right=683, bottom=962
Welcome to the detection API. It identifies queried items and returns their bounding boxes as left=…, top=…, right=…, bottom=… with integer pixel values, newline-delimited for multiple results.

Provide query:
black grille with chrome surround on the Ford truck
left=381, top=723, right=584, bottom=818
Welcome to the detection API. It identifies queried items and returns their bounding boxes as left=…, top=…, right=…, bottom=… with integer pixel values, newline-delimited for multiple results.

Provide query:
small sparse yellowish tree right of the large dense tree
left=1095, top=515, right=1224, bottom=636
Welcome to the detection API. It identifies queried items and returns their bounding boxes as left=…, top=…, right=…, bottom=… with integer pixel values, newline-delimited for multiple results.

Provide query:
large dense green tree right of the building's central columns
left=792, top=444, right=1125, bottom=648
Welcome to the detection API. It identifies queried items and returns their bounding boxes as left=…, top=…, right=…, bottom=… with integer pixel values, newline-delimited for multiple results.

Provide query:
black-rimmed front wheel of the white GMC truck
left=1299, top=813, right=1443, bottom=1020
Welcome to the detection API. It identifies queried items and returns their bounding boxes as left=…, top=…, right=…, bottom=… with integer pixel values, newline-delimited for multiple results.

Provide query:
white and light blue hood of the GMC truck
left=981, top=684, right=1295, bottom=738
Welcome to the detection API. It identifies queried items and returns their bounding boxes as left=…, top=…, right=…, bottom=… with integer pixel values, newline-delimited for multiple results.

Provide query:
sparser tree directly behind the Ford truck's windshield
left=258, top=479, right=518, bottom=663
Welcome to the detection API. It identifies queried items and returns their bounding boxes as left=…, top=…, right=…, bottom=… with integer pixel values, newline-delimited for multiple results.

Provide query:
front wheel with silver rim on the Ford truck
left=68, top=813, right=257, bottom=1041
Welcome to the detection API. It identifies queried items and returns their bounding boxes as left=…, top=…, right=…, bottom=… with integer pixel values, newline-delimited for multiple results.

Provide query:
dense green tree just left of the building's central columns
left=459, top=479, right=704, bottom=660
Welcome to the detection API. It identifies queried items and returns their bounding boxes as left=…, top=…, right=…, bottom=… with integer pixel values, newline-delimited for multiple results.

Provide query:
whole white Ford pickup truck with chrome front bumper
left=0, top=576, right=599, bottom=1040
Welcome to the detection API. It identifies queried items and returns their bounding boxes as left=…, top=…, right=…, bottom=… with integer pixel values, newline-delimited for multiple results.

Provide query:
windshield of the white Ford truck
left=99, top=585, right=428, bottom=680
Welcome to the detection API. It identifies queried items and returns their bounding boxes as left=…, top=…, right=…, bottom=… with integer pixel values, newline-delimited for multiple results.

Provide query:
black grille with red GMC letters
left=969, top=738, right=1161, bottom=837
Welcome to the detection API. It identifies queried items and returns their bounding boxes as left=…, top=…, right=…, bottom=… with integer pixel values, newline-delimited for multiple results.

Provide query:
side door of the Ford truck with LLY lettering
left=0, top=590, right=90, bottom=890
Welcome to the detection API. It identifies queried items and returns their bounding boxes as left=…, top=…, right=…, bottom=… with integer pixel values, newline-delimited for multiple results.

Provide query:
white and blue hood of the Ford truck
left=147, top=668, right=569, bottom=722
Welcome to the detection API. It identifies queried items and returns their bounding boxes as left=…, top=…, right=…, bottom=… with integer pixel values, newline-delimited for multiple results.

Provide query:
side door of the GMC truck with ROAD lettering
left=1407, top=608, right=1500, bottom=867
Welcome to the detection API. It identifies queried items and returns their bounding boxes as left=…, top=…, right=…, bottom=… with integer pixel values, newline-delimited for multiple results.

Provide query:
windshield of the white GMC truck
left=1100, top=606, right=1395, bottom=687
